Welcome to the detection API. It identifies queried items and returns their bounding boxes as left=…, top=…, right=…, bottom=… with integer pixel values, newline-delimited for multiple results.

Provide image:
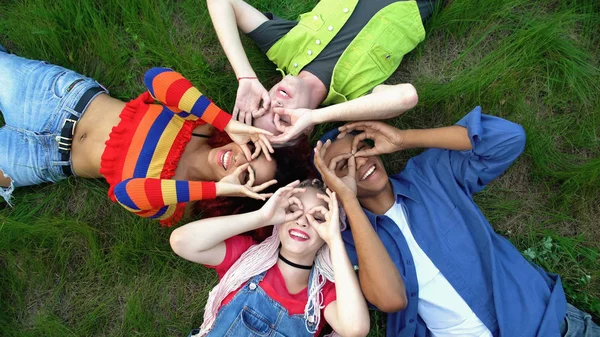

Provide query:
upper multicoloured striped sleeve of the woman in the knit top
left=144, top=68, right=231, bottom=131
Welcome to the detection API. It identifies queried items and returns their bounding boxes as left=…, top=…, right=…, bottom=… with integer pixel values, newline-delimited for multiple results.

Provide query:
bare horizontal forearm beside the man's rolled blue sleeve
left=401, top=125, right=472, bottom=151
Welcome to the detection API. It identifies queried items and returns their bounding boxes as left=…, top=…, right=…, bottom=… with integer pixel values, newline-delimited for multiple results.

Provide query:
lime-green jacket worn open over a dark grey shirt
left=267, top=0, right=425, bottom=105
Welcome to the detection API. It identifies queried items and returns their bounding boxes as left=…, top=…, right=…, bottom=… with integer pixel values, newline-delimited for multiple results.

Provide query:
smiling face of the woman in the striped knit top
left=208, top=143, right=277, bottom=185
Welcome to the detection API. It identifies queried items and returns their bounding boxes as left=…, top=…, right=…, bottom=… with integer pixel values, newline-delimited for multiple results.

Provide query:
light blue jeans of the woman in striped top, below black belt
left=0, top=43, right=106, bottom=202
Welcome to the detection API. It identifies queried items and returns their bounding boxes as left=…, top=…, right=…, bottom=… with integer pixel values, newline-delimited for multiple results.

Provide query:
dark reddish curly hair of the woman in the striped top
left=192, top=132, right=314, bottom=241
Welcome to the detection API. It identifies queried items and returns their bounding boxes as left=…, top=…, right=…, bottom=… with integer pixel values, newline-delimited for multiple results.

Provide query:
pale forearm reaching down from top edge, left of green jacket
left=207, top=0, right=256, bottom=78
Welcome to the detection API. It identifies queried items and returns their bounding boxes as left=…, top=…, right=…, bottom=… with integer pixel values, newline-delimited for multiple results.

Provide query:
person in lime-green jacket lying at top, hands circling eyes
left=207, top=0, right=435, bottom=145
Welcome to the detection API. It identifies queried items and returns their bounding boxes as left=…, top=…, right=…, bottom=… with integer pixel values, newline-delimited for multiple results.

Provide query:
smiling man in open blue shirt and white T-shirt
left=315, top=107, right=600, bottom=337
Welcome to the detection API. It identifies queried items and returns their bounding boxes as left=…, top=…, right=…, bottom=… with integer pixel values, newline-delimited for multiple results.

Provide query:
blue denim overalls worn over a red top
left=190, top=270, right=316, bottom=337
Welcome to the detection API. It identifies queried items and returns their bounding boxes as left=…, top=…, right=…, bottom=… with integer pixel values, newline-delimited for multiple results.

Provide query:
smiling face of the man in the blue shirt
left=323, top=134, right=389, bottom=198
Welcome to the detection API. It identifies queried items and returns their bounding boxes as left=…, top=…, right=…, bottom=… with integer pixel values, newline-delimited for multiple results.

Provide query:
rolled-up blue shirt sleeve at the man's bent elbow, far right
left=450, top=107, right=525, bottom=193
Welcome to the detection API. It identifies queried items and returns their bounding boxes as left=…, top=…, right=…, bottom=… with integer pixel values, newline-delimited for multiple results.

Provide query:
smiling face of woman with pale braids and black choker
left=279, top=187, right=327, bottom=259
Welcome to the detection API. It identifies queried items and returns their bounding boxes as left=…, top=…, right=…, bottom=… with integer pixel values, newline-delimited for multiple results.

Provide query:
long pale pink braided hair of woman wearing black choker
left=199, top=179, right=346, bottom=336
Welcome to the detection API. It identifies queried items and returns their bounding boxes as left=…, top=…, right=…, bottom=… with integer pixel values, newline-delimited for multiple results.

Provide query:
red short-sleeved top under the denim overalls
left=207, top=235, right=336, bottom=336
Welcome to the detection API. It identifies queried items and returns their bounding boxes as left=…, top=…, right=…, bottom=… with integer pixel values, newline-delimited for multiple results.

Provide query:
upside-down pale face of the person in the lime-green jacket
left=252, top=75, right=311, bottom=136
